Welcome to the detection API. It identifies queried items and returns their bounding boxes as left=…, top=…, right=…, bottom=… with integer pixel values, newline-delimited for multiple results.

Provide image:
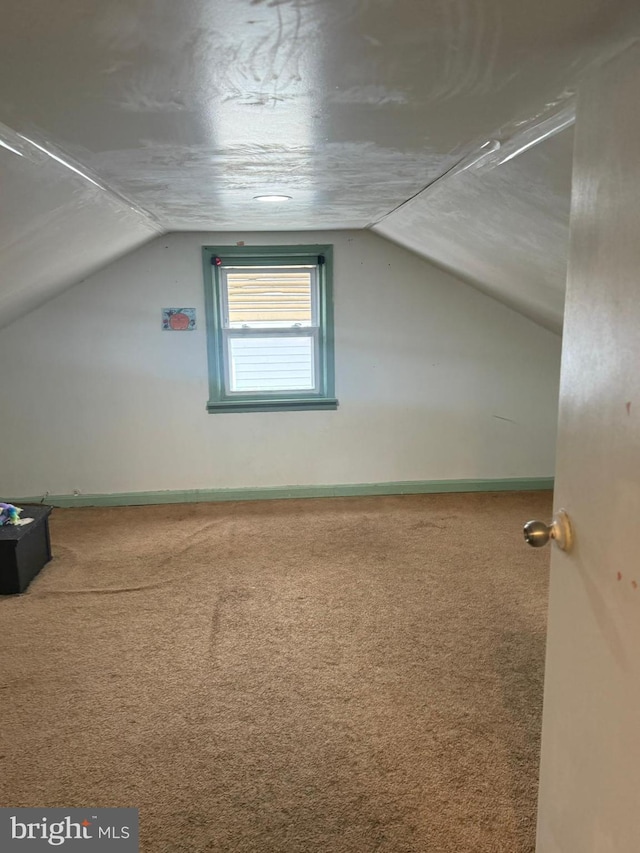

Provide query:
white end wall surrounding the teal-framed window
left=0, top=231, right=560, bottom=496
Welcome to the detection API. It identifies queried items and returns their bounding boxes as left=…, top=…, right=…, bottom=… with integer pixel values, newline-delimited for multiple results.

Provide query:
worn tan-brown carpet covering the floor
left=0, top=493, right=551, bottom=853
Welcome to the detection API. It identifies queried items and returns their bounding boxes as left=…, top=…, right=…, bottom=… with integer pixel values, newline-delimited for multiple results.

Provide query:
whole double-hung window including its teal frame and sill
left=203, top=246, right=338, bottom=412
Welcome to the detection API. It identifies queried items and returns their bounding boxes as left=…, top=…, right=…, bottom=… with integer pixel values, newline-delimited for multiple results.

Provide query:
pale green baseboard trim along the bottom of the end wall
left=11, top=477, right=554, bottom=507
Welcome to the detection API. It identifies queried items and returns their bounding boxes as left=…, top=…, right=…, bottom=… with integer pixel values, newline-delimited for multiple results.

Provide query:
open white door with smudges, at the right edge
left=537, top=41, right=640, bottom=853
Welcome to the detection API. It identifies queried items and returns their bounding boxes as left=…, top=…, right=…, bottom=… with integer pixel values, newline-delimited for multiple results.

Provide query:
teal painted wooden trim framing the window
left=202, top=245, right=338, bottom=414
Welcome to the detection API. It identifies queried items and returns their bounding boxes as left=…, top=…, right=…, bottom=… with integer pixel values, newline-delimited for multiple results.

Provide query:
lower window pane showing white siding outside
left=228, top=335, right=315, bottom=393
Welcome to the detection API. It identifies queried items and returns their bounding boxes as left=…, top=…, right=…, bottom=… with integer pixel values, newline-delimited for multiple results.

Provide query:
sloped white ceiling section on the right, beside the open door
left=374, top=128, right=573, bottom=332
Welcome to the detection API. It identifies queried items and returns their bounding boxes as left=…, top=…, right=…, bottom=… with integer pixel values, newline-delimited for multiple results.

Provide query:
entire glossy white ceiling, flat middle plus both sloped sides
left=0, top=0, right=638, bottom=328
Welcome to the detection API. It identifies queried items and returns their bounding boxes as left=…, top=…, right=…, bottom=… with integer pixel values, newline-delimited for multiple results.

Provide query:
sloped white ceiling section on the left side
left=0, top=121, right=160, bottom=325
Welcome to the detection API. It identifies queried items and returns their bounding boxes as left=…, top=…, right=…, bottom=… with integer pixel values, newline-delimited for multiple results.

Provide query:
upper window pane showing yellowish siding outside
left=223, top=267, right=315, bottom=329
